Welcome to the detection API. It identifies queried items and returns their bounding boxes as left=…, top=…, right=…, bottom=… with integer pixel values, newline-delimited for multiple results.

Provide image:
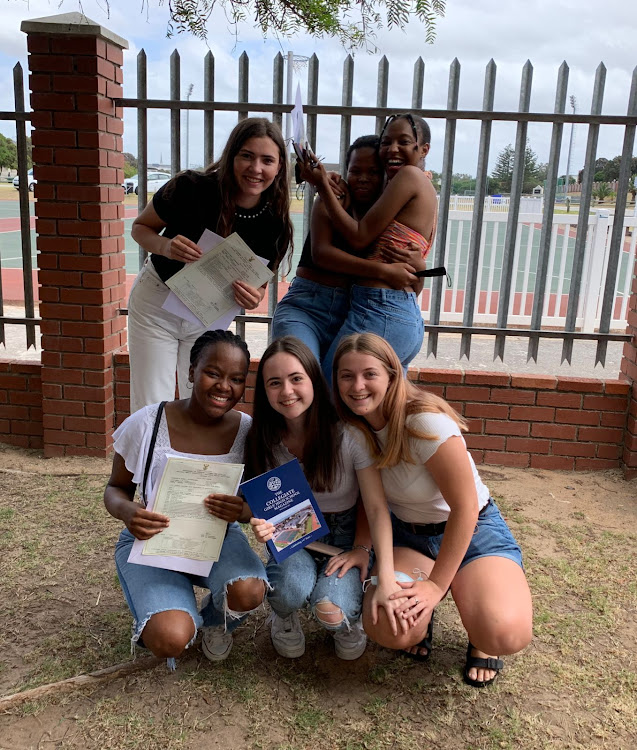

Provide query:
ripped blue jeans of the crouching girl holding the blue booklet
left=266, top=506, right=367, bottom=631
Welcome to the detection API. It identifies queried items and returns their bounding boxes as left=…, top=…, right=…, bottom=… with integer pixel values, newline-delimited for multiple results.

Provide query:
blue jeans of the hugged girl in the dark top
left=272, top=276, right=349, bottom=368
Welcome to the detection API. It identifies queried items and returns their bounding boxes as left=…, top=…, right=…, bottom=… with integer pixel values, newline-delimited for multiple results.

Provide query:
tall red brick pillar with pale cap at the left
left=21, top=13, right=128, bottom=457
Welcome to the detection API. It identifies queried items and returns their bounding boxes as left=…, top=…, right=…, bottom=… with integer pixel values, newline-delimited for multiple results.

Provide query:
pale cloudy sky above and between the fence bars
left=0, top=0, right=637, bottom=174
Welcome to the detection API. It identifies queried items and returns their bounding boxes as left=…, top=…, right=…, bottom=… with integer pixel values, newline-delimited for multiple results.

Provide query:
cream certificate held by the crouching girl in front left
left=128, top=456, right=243, bottom=576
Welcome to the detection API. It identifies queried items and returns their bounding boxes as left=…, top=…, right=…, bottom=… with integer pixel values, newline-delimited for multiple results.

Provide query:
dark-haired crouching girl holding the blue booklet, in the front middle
left=245, top=336, right=407, bottom=659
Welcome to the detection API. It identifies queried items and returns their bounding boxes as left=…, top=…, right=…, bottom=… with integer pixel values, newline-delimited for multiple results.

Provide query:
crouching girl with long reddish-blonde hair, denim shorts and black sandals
left=334, top=333, right=532, bottom=687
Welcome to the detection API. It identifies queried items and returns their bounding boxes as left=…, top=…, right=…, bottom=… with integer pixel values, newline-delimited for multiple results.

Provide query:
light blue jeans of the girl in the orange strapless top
left=321, top=284, right=425, bottom=383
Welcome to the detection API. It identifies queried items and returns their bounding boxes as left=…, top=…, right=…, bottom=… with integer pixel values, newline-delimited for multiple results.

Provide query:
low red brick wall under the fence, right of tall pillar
left=108, top=353, right=637, bottom=470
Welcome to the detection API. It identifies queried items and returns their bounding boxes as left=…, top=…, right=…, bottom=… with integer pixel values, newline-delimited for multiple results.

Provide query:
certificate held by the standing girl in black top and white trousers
left=166, top=232, right=274, bottom=326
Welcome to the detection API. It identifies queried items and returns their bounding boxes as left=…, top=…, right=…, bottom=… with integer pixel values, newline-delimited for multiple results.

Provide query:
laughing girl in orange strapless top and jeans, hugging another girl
left=301, top=114, right=437, bottom=372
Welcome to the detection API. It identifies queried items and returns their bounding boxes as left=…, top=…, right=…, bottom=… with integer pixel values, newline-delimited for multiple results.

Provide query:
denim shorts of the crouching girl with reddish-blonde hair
left=392, top=499, right=524, bottom=570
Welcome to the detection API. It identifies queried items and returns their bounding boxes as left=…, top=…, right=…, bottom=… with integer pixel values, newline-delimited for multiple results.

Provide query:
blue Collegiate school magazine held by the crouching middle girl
left=239, top=458, right=329, bottom=562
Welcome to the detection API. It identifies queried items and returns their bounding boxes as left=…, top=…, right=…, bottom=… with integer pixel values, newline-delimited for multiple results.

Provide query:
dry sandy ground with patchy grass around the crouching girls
left=0, top=446, right=637, bottom=750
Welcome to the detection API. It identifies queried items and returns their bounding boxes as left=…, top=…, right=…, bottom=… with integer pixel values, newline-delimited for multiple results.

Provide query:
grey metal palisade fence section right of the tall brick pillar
left=116, top=51, right=637, bottom=365
